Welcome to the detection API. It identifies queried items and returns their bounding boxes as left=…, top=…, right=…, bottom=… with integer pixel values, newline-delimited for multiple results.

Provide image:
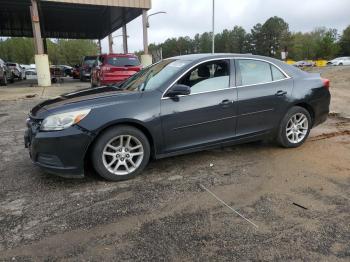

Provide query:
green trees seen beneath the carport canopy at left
left=0, top=37, right=99, bottom=65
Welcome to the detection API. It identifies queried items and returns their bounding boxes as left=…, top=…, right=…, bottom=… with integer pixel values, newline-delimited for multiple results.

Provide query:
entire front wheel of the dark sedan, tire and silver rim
left=91, top=125, right=150, bottom=181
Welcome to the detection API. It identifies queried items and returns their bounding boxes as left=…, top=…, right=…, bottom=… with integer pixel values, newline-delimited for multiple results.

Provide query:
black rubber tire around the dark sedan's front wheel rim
left=91, top=125, right=151, bottom=181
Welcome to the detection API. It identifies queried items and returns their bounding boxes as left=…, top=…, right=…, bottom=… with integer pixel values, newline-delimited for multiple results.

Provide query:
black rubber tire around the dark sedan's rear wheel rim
left=277, top=106, right=312, bottom=148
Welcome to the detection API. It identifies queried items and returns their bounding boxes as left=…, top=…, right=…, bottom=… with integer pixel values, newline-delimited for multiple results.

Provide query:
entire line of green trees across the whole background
left=0, top=16, right=350, bottom=65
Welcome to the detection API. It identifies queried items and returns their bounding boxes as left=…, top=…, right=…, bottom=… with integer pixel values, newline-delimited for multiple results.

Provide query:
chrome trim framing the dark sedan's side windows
left=161, top=56, right=291, bottom=100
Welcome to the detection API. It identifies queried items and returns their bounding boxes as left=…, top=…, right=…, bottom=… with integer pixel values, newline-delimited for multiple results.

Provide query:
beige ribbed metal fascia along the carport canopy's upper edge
left=42, top=0, right=151, bottom=9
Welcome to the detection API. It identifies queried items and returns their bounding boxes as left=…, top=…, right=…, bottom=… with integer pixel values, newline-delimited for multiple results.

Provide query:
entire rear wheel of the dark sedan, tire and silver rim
left=277, top=106, right=312, bottom=148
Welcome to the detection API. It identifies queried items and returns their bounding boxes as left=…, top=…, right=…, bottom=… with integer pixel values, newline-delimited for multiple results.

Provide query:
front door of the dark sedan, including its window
left=161, top=59, right=237, bottom=153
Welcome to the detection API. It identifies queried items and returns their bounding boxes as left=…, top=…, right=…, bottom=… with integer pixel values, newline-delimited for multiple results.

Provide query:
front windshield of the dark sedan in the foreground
left=119, top=59, right=191, bottom=91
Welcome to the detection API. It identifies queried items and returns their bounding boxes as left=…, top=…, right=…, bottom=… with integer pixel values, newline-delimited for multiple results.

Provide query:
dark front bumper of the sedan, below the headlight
left=24, top=120, right=93, bottom=177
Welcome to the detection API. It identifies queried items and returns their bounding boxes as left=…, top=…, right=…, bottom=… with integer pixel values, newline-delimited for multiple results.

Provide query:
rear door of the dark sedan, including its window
left=235, top=58, right=293, bottom=136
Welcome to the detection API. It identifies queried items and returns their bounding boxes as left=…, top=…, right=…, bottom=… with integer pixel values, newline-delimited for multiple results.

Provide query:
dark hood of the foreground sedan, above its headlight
left=30, top=86, right=140, bottom=119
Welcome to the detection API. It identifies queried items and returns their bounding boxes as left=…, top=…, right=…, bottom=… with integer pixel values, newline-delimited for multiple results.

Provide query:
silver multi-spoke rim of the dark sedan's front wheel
left=102, top=135, right=144, bottom=176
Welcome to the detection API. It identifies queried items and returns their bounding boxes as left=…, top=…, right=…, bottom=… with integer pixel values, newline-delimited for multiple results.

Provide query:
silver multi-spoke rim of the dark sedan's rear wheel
left=286, top=113, right=309, bottom=144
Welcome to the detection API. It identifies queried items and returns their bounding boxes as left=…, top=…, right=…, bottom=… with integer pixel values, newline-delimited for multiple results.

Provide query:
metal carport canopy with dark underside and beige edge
left=0, top=0, right=151, bottom=39
